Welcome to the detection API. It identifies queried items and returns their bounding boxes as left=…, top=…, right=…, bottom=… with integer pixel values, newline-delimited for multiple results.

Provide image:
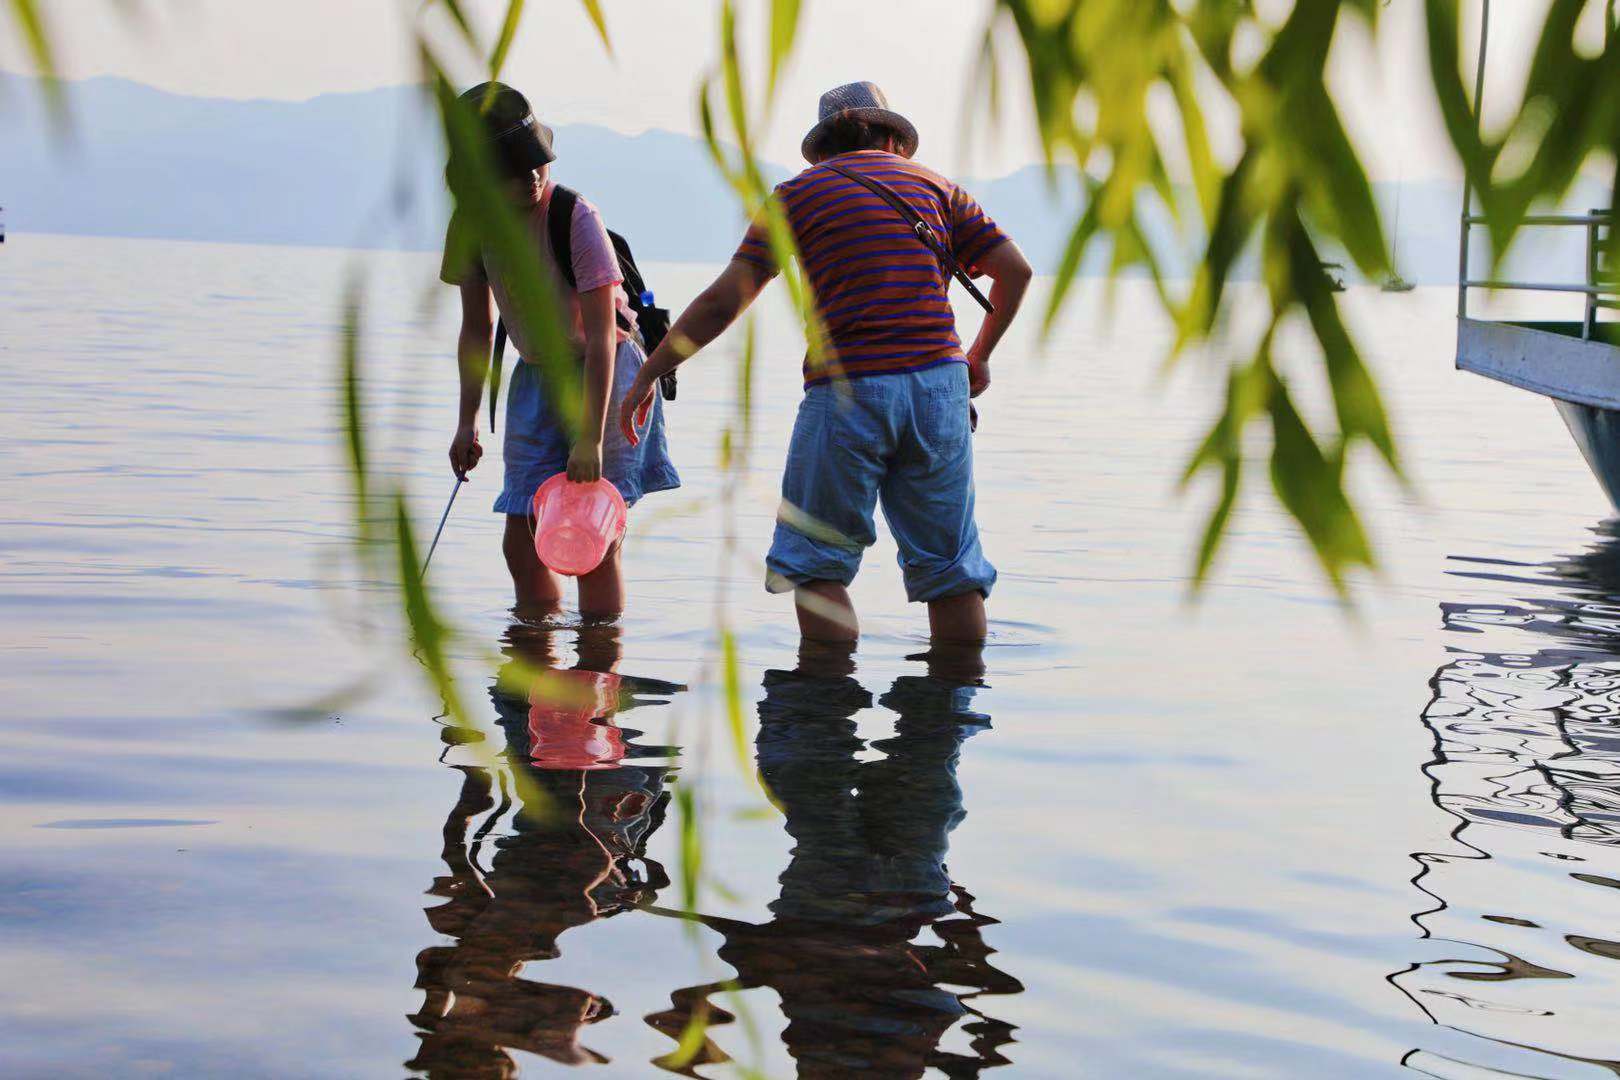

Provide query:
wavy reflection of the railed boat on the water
left=1392, top=524, right=1620, bottom=1075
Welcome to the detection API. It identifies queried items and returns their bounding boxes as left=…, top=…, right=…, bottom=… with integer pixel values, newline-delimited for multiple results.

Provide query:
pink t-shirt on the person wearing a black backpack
left=439, top=183, right=635, bottom=356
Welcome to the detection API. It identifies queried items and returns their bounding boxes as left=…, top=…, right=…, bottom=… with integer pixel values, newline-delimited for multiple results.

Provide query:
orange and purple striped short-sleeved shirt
left=734, top=151, right=1006, bottom=385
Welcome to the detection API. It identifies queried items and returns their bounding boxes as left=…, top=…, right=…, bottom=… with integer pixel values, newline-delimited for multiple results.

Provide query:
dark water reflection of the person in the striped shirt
left=650, top=644, right=1022, bottom=1077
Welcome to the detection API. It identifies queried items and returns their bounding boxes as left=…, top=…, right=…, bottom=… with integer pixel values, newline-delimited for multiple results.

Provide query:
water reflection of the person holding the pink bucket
left=407, top=625, right=680, bottom=1077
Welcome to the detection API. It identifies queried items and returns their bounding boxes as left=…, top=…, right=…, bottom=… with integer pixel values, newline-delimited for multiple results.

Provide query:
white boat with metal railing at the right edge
left=1456, top=6, right=1620, bottom=510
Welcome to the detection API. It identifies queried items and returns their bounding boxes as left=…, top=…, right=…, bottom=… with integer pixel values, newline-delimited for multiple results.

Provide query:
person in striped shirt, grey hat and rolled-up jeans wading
left=620, top=83, right=1032, bottom=641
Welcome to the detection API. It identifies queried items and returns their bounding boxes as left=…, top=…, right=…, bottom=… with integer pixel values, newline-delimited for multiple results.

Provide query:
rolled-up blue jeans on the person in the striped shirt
left=765, top=361, right=996, bottom=602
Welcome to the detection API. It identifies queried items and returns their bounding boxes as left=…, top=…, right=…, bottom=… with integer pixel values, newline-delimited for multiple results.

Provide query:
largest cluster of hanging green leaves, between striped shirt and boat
left=978, top=0, right=1419, bottom=586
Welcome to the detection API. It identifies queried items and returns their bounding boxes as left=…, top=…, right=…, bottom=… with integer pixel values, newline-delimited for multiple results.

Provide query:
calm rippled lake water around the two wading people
left=0, top=235, right=1620, bottom=1078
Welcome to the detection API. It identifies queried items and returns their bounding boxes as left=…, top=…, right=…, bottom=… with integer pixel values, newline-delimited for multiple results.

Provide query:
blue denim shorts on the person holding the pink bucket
left=496, top=342, right=680, bottom=517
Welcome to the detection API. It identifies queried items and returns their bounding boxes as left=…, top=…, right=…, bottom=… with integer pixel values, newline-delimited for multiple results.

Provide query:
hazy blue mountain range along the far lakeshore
left=0, top=74, right=1605, bottom=283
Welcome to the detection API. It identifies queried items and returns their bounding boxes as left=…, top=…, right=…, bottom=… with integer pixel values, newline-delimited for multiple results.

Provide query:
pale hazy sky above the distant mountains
left=0, top=0, right=1568, bottom=180
